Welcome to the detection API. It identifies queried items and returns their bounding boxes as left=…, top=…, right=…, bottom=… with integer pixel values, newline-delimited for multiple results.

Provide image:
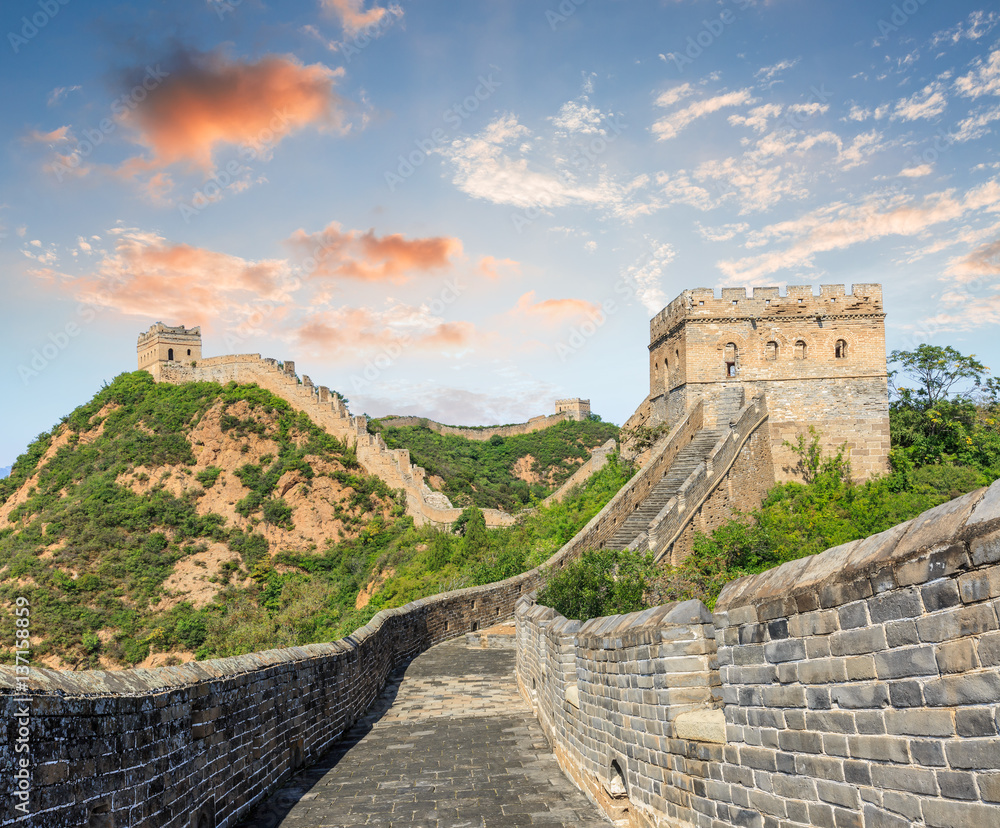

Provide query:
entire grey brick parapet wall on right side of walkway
left=516, top=482, right=1000, bottom=828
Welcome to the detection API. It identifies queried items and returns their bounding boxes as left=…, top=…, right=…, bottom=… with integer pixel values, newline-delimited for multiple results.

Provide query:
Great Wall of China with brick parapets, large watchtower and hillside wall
left=9, top=285, right=984, bottom=828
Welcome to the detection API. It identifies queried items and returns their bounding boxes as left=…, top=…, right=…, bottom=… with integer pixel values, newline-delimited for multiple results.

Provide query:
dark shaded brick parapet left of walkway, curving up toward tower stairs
left=0, top=410, right=712, bottom=828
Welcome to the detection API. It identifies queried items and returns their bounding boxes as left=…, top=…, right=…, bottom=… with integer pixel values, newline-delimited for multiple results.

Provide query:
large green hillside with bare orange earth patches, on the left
left=0, top=372, right=629, bottom=669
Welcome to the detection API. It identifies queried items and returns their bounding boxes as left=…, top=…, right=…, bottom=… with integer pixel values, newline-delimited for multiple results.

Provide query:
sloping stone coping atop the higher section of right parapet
left=715, top=481, right=1000, bottom=620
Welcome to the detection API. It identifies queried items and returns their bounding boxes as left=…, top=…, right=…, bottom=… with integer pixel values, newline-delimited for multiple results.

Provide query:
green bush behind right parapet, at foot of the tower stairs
left=538, top=549, right=655, bottom=621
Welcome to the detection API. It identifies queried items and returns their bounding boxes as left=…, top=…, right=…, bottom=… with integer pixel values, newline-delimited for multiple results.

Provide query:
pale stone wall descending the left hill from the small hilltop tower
left=146, top=354, right=514, bottom=527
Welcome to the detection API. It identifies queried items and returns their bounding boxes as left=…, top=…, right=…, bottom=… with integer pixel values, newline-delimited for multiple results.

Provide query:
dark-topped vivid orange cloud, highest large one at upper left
left=119, top=52, right=343, bottom=170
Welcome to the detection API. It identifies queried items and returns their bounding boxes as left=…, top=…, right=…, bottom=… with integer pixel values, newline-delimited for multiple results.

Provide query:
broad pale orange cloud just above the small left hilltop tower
left=39, top=228, right=290, bottom=325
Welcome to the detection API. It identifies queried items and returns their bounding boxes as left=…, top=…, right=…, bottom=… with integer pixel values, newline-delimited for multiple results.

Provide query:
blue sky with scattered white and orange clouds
left=0, top=0, right=1000, bottom=464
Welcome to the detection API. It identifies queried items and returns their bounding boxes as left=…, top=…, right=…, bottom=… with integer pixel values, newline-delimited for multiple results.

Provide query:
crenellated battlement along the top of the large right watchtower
left=649, top=283, right=883, bottom=347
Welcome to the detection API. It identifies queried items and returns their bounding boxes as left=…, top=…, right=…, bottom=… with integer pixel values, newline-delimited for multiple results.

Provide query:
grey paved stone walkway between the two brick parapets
left=242, top=639, right=610, bottom=828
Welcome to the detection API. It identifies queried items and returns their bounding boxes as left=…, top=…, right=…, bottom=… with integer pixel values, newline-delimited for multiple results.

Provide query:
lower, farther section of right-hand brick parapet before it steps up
left=516, top=597, right=723, bottom=826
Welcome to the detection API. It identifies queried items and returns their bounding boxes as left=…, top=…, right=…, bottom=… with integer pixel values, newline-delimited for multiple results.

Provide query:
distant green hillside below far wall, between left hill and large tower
left=371, top=418, right=618, bottom=512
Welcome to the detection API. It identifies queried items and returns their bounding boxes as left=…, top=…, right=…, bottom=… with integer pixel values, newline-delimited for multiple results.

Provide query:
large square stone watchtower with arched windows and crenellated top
left=649, top=284, right=889, bottom=481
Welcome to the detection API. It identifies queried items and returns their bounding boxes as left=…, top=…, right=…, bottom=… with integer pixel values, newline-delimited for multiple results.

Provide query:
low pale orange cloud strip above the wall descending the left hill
left=292, top=304, right=476, bottom=356
